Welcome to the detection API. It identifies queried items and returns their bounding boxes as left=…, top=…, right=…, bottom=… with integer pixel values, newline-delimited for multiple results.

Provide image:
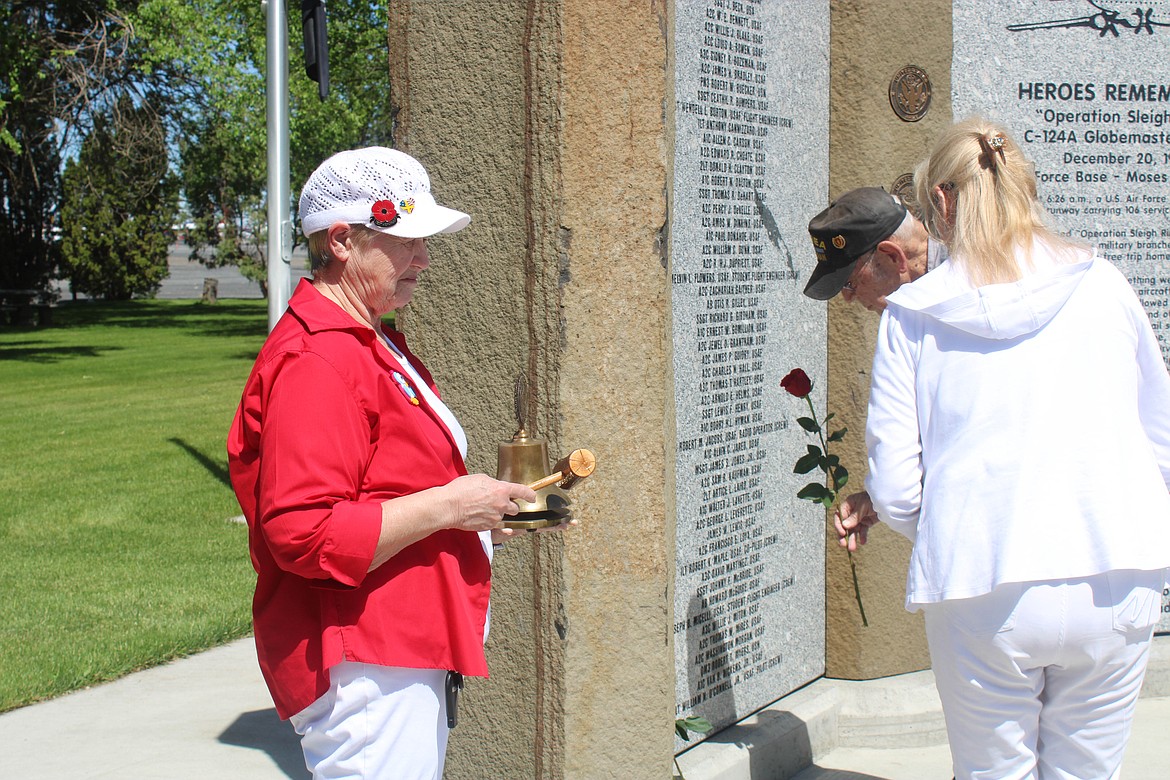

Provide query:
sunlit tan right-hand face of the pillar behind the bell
left=559, top=0, right=675, bottom=779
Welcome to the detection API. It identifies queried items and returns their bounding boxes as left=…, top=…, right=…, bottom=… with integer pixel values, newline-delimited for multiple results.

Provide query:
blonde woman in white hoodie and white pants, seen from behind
left=856, top=119, right=1170, bottom=780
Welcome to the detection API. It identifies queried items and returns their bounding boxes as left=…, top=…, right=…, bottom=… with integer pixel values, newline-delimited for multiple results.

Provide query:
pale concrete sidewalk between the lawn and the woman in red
left=0, top=637, right=309, bottom=780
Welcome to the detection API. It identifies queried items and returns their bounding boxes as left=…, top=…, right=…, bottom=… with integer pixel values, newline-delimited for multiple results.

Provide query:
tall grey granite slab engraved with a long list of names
left=669, top=0, right=828, bottom=747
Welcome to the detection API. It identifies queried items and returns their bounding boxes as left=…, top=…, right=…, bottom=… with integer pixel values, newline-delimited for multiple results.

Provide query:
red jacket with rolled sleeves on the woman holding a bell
left=227, top=281, right=491, bottom=718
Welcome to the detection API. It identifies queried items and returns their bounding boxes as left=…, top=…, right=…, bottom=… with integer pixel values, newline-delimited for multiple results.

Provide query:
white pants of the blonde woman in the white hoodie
left=924, top=571, right=1165, bottom=780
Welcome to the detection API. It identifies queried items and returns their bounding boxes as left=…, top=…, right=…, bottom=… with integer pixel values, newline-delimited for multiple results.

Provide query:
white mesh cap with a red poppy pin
left=297, top=146, right=472, bottom=239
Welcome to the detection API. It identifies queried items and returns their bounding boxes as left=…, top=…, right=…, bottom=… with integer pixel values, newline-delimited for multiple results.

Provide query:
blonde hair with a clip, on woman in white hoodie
left=914, top=117, right=1078, bottom=285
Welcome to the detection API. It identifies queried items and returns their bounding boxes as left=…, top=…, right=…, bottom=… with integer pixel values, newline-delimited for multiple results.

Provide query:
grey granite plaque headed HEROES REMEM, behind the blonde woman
left=951, top=0, right=1170, bottom=631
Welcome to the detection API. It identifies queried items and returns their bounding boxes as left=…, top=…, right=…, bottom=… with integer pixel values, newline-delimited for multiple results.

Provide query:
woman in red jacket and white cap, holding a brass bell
left=228, top=147, right=552, bottom=780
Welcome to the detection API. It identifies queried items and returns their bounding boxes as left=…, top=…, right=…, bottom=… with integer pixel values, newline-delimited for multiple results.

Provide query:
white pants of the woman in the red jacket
left=290, top=661, right=448, bottom=780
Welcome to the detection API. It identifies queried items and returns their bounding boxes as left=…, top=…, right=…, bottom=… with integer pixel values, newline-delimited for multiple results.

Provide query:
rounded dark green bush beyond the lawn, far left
left=61, top=103, right=178, bottom=301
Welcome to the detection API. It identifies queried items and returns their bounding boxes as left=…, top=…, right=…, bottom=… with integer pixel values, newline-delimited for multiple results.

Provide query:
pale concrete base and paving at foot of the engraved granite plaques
left=677, top=635, right=1170, bottom=780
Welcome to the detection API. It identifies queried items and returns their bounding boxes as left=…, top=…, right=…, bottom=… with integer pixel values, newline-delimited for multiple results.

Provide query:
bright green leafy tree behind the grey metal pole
left=136, top=0, right=391, bottom=288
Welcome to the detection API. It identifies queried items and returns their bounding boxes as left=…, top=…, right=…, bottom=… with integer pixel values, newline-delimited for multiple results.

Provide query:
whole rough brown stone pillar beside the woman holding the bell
left=390, top=0, right=674, bottom=780
